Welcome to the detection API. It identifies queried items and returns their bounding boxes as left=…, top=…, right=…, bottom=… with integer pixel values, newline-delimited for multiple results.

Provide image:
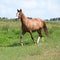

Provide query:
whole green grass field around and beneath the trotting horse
left=0, top=21, right=60, bottom=60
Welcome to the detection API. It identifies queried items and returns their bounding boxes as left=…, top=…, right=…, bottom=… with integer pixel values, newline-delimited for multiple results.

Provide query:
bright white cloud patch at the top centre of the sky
left=21, top=0, right=37, bottom=9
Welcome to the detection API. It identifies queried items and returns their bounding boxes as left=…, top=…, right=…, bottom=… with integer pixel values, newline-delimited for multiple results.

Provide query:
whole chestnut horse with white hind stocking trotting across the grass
left=17, top=9, right=48, bottom=45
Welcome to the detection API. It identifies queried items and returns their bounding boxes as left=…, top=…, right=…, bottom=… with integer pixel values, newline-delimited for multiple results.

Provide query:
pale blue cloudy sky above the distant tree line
left=0, top=0, right=60, bottom=19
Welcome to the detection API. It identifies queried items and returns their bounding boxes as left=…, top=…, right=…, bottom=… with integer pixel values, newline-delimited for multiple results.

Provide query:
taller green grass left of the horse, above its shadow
left=0, top=21, right=21, bottom=46
